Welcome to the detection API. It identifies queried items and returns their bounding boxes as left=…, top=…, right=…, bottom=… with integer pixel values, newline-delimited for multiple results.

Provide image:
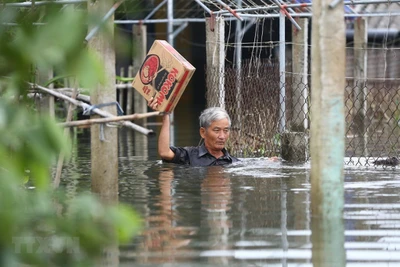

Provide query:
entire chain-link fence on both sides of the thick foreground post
left=207, top=59, right=400, bottom=165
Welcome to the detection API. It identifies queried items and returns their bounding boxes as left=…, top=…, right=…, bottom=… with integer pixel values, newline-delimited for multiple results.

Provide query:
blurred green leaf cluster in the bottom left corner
left=0, top=176, right=140, bottom=266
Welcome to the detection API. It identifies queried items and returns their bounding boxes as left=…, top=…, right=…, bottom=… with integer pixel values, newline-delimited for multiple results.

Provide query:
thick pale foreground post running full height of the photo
left=311, top=0, right=346, bottom=266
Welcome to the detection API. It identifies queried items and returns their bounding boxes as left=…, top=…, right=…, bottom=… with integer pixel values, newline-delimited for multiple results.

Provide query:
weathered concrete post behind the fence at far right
left=354, top=18, right=368, bottom=157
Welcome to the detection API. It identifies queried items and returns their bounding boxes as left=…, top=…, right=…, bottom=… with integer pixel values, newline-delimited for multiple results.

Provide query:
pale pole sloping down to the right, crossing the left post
left=28, top=83, right=154, bottom=135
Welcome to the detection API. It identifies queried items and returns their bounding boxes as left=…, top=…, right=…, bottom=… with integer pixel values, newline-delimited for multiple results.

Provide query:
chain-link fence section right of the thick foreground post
left=345, top=79, right=400, bottom=165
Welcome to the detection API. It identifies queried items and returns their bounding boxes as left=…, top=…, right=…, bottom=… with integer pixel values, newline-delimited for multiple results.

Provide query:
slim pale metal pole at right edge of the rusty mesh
left=279, top=9, right=286, bottom=133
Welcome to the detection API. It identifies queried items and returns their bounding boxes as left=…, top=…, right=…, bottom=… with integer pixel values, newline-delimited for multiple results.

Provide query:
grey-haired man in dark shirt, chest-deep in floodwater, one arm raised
left=149, top=98, right=238, bottom=166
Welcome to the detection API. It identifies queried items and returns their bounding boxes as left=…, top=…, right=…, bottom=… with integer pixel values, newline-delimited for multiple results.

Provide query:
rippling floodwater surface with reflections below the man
left=62, top=131, right=400, bottom=266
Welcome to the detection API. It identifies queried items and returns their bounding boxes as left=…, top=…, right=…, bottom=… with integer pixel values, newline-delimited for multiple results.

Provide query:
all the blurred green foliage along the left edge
left=0, top=1, right=140, bottom=266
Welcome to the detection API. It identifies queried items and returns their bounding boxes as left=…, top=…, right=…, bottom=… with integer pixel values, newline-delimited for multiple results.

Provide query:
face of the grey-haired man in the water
left=200, top=119, right=230, bottom=151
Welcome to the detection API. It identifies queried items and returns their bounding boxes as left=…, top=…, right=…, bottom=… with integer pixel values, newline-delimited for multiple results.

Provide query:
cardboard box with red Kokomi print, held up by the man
left=132, top=40, right=196, bottom=112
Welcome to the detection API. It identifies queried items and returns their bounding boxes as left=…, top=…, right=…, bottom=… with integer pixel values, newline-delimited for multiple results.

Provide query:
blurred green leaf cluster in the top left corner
left=0, top=5, right=104, bottom=91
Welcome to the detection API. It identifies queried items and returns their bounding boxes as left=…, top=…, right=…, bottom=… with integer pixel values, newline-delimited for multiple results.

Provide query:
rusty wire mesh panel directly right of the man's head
left=207, top=61, right=280, bottom=157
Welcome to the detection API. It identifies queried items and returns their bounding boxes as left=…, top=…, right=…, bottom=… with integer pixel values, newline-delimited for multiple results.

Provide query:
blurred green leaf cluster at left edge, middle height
left=0, top=98, right=69, bottom=190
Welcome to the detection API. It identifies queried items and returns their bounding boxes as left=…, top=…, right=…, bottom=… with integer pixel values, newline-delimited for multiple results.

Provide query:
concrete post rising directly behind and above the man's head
left=206, top=16, right=225, bottom=108
